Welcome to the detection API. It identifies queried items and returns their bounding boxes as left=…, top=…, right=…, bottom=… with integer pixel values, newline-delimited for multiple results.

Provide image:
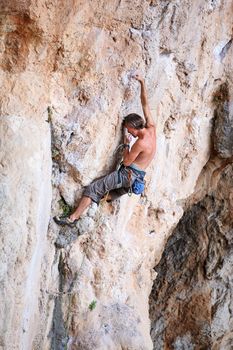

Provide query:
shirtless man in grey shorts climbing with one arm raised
left=54, top=75, right=156, bottom=227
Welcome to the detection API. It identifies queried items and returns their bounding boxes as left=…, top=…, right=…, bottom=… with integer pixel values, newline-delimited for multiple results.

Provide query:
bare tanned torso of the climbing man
left=133, top=126, right=156, bottom=170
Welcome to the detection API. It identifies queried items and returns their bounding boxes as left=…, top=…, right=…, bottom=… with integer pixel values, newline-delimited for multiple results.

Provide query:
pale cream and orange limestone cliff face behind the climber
left=0, top=0, right=232, bottom=350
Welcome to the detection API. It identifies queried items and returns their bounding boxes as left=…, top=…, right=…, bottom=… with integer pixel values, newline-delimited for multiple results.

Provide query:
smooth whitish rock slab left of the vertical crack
left=0, top=116, right=51, bottom=349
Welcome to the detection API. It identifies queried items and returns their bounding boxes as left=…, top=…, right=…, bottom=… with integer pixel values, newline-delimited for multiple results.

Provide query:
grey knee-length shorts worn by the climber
left=83, top=165, right=143, bottom=204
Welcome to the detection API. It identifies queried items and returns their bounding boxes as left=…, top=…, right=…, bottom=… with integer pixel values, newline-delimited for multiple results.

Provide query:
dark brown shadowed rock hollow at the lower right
left=150, top=165, right=233, bottom=350
